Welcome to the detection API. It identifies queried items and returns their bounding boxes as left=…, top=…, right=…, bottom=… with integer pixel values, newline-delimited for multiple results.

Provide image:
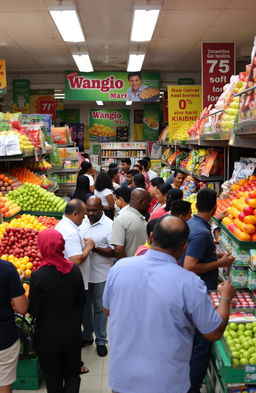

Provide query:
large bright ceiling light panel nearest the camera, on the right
left=131, top=9, right=160, bottom=42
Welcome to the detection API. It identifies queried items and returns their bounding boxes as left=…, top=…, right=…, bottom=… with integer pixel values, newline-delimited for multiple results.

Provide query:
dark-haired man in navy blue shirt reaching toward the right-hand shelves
left=184, top=188, right=234, bottom=393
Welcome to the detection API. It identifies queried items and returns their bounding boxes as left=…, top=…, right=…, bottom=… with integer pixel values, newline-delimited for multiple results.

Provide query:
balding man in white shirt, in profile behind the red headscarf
left=55, top=199, right=95, bottom=289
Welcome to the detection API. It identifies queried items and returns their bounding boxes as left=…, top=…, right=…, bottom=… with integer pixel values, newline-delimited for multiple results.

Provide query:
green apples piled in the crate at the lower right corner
left=224, top=322, right=256, bottom=366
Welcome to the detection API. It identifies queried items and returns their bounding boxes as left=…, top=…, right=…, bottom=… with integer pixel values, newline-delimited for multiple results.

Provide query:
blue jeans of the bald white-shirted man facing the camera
left=83, top=281, right=108, bottom=345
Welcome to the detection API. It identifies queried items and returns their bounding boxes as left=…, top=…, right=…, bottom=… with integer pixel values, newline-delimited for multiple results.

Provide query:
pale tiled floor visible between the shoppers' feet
left=14, top=345, right=111, bottom=393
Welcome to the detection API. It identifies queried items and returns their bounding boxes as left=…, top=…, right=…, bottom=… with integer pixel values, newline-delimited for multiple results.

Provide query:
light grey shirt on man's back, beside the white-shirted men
left=111, top=206, right=147, bottom=256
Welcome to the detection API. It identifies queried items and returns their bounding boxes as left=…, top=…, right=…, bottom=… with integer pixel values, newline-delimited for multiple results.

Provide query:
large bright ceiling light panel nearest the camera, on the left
left=48, top=6, right=85, bottom=42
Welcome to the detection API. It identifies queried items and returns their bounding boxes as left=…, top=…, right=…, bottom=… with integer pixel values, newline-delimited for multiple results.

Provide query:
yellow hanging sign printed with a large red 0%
left=168, top=85, right=202, bottom=142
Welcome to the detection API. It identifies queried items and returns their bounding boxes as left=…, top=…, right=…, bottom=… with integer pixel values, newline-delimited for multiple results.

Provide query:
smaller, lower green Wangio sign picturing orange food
left=89, top=109, right=130, bottom=141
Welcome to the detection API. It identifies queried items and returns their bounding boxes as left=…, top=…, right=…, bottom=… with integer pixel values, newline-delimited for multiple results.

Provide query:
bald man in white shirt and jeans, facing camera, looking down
left=79, top=196, right=114, bottom=356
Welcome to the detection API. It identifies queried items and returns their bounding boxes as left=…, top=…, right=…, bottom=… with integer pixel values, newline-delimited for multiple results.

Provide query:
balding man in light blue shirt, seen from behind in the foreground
left=103, top=216, right=235, bottom=393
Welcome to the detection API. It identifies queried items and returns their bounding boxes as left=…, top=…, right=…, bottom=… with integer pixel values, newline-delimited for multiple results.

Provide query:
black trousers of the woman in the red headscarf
left=37, top=347, right=81, bottom=393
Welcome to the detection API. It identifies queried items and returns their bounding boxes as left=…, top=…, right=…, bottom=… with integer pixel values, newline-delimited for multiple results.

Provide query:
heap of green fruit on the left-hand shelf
left=8, top=183, right=66, bottom=212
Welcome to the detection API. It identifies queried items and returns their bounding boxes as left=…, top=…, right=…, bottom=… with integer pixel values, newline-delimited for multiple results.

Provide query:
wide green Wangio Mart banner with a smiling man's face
left=65, top=71, right=160, bottom=102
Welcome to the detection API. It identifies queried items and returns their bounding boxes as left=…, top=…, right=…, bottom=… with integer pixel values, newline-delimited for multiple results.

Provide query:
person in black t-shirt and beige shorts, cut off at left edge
left=0, top=260, right=28, bottom=393
